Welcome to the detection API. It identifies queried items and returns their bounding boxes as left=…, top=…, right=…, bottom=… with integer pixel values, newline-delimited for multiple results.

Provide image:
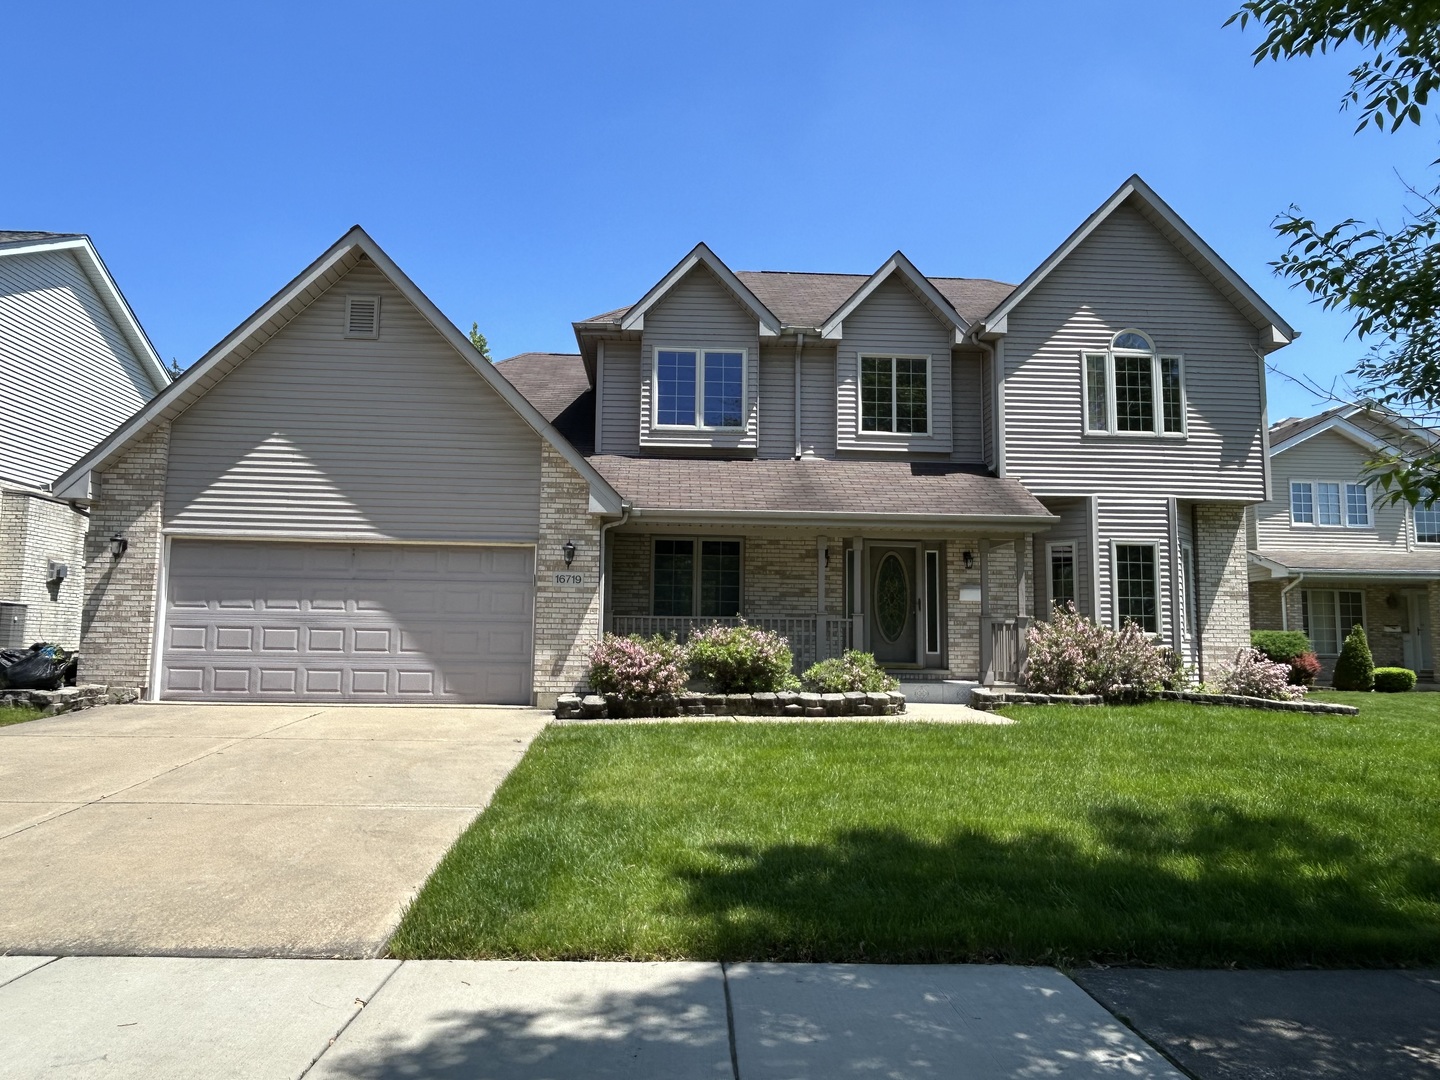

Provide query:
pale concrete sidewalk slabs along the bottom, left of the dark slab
left=0, top=956, right=1181, bottom=1080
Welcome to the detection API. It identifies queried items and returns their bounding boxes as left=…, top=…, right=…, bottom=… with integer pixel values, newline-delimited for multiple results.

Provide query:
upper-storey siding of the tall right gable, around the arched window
left=1004, top=206, right=1264, bottom=500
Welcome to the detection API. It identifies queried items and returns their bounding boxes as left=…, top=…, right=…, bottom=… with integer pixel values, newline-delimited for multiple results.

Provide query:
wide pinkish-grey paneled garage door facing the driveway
left=160, top=539, right=534, bottom=704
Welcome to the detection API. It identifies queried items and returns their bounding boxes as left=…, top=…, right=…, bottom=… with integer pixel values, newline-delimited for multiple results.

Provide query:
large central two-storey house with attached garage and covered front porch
left=58, top=179, right=1293, bottom=704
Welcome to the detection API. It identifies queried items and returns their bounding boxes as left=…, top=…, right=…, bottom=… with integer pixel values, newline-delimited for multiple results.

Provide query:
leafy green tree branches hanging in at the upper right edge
left=1225, top=0, right=1440, bottom=504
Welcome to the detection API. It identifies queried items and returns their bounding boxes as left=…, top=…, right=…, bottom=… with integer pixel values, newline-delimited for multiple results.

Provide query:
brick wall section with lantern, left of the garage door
left=79, top=423, right=170, bottom=691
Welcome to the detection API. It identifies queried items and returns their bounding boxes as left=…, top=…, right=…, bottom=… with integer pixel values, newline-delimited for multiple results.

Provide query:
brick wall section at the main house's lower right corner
left=1195, top=503, right=1250, bottom=680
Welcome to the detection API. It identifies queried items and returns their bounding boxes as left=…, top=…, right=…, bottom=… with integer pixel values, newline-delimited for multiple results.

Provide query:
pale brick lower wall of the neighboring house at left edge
left=0, top=488, right=89, bottom=649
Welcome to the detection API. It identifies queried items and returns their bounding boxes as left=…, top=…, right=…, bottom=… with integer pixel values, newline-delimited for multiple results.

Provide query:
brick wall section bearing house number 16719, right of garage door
left=534, top=442, right=600, bottom=708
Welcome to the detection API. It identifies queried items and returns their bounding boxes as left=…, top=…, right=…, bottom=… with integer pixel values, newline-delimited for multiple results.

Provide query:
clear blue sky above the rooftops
left=0, top=0, right=1436, bottom=419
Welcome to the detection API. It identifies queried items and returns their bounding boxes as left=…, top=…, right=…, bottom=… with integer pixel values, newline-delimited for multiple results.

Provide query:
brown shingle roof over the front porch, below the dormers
left=590, top=454, right=1050, bottom=520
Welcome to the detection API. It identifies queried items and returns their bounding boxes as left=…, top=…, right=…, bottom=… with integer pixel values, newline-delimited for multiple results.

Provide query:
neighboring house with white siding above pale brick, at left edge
left=0, top=230, right=170, bottom=648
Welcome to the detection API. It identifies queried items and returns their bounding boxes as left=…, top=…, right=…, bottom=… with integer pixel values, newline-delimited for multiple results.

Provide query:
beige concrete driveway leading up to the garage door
left=0, top=704, right=547, bottom=958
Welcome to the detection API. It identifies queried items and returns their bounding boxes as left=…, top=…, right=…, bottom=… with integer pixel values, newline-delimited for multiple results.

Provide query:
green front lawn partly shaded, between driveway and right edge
left=390, top=694, right=1440, bottom=966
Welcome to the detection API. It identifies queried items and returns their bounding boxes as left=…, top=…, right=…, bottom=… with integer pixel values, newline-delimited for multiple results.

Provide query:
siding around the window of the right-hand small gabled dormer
left=837, top=276, right=955, bottom=454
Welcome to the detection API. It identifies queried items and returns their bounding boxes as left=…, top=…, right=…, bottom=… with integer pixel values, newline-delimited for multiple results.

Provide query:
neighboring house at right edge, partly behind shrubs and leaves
left=1248, top=405, right=1440, bottom=678
